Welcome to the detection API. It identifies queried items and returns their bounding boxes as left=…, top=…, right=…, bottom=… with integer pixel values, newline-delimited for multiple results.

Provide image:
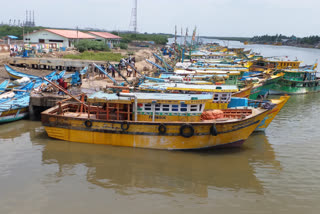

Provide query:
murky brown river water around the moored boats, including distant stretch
left=0, top=43, right=320, bottom=214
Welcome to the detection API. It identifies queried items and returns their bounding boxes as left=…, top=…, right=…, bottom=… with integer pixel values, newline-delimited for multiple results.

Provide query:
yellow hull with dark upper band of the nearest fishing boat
left=42, top=110, right=268, bottom=150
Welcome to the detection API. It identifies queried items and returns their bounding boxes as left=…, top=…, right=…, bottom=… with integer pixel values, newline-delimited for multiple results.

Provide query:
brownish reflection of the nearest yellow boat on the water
left=32, top=131, right=281, bottom=198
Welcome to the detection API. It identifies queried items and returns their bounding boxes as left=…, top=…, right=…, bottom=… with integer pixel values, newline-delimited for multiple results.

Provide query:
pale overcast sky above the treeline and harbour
left=0, top=0, right=320, bottom=36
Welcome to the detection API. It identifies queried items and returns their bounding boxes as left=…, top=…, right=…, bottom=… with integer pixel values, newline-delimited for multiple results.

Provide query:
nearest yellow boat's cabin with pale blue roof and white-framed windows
left=87, top=92, right=213, bottom=122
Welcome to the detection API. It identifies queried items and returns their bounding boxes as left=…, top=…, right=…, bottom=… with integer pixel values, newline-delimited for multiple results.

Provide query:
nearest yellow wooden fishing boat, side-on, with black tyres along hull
left=42, top=92, right=271, bottom=150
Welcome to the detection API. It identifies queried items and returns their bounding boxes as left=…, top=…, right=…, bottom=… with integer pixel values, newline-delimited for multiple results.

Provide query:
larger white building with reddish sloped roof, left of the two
left=24, top=29, right=96, bottom=48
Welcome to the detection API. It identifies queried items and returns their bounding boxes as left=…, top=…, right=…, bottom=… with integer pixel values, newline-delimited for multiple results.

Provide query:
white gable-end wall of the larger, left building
left=24, top=30, right=69, bottom=47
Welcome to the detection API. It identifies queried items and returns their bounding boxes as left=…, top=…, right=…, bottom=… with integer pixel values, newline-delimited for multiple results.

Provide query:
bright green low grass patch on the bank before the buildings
left=63, top=51, right=124, bottom=62
